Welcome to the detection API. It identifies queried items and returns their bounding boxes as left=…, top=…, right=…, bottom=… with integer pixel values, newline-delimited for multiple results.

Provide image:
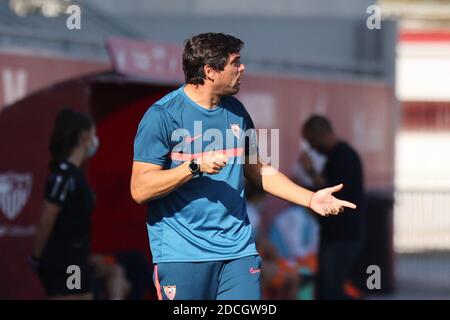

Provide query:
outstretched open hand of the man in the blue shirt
left=310, top=184, right=356, bottom=216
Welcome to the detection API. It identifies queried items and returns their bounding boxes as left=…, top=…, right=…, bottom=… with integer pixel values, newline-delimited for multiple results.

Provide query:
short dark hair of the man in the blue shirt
left=183, top=32, right=244, bottom=85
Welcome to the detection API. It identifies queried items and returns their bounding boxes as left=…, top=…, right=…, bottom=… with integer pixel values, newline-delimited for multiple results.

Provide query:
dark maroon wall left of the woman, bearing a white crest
left=0, top=83, right=89, bottom=299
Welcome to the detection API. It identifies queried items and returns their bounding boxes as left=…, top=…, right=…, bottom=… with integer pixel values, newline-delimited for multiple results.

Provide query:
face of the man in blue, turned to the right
left=213, top=53, right=245, bottom=96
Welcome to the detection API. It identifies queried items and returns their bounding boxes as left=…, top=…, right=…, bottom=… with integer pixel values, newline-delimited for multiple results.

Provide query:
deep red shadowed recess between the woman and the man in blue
left=88, top=84, right=170, bottom=257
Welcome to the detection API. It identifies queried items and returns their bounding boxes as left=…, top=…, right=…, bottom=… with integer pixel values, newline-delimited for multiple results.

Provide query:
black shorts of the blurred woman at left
left=38, top=264, right=93, bottom=296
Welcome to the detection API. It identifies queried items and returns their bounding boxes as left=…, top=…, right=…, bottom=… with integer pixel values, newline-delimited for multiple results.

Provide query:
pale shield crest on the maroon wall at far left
left=0, top=172, right=33, bottom=220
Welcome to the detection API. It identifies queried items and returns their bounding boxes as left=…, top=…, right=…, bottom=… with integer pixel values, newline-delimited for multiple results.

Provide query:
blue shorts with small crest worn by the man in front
left=153, top=255, right=261, bottom=300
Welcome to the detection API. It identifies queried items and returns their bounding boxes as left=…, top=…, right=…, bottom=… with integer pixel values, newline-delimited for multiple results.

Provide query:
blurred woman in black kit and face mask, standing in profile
left=32, top=109, right=98, bottom=299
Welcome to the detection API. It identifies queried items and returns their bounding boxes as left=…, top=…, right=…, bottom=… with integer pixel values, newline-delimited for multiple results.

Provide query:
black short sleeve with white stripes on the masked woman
left=45, top=172, right=75, bottom=206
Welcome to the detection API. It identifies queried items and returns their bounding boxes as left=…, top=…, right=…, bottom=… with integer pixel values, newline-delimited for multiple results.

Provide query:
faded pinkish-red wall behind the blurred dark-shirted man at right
left=238, top=75, right=399, bottom=220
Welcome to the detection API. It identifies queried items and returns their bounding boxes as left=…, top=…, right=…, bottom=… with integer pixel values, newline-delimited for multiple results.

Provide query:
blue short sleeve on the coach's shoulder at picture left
left=133, top=106, right=171, bottom=166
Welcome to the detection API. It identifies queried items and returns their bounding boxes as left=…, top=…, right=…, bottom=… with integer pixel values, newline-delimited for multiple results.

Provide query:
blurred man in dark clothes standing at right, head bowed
left=301, top=115, right=364, bottom=299
